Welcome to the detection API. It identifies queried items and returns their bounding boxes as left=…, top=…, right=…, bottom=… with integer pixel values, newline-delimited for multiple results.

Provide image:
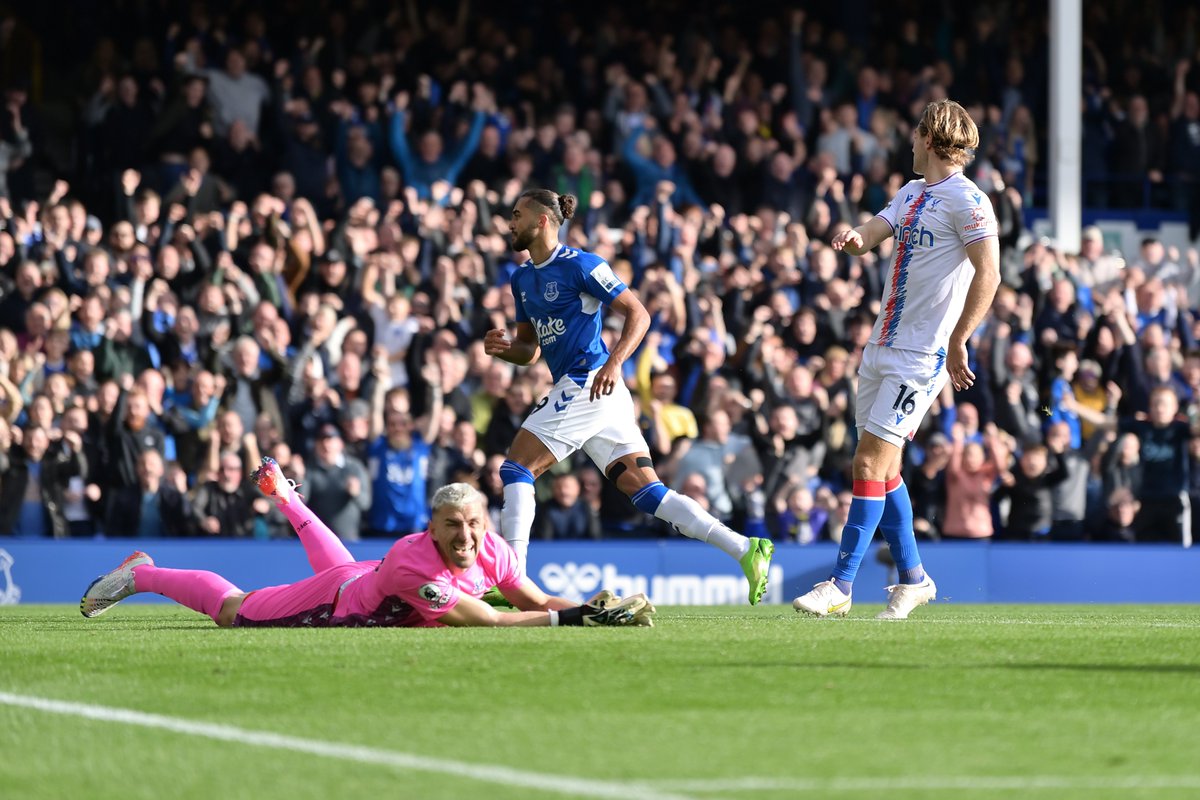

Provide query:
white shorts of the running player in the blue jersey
left=521, top=367, right=650, bottom=471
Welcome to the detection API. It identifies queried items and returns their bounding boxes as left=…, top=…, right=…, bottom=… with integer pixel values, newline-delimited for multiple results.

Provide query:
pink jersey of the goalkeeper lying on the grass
left=330, top=531, right=524, bottom=627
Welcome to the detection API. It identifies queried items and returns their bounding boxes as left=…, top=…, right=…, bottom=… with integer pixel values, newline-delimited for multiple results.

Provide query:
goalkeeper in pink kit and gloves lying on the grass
left=79, top=458, right=654, bottom=627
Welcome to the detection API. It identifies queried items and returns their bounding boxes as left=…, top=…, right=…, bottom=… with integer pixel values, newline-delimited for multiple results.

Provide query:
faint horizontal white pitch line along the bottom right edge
left=647, top=775, right=1200, bottom=794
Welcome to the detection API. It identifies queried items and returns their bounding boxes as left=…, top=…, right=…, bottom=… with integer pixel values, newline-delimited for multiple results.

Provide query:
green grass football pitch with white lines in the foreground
left=0, top=603, right=1200, bottom=800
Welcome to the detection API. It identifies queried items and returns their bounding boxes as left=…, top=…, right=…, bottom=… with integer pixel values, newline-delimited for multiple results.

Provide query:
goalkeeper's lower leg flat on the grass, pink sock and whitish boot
left=79, top=552, right=241, bottom=622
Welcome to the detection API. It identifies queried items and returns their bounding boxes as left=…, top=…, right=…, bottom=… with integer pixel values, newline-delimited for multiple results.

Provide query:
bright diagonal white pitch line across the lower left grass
left=0, top=692, right=690, bottom=800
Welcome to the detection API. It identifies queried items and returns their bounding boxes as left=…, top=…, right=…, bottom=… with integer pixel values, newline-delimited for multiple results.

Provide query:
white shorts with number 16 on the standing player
left=854, top=344, right=947, bottom=447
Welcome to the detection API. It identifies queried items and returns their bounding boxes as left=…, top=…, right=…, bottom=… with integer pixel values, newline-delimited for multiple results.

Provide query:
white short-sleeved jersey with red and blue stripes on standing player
left=871, top=172, right=997, bottom=354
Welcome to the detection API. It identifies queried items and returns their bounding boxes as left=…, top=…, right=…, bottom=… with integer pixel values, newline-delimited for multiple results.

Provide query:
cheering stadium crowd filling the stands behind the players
left=0, top=0, right=1200, bottom=543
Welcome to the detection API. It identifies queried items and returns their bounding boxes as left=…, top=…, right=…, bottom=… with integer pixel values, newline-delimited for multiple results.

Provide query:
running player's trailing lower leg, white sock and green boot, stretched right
left=631, top=479, right=775, bottom=606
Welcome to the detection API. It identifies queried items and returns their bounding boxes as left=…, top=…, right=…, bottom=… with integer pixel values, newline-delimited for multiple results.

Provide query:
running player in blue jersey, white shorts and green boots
left=484, top=190, right=774, bottom=604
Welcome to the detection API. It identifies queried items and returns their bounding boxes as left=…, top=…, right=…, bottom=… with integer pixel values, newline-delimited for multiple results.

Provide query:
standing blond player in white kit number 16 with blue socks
left=792, top=100, right=1000, bottom=619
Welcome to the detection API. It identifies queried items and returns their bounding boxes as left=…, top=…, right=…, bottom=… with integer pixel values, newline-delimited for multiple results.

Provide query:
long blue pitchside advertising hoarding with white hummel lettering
left=0, top=539, right=1200, bottom=606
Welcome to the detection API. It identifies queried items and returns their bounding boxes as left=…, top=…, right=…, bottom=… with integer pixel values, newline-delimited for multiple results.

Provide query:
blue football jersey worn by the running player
left=511, top=245, right=625, bottom=386
